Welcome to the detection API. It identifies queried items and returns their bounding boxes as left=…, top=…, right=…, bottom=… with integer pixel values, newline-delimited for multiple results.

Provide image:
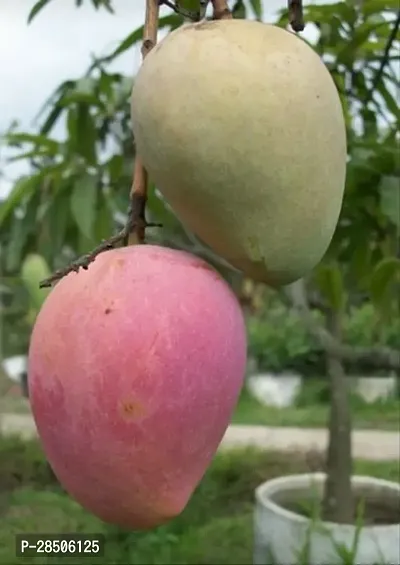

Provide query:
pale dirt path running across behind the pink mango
left=0, top=414, right=400, bottom=461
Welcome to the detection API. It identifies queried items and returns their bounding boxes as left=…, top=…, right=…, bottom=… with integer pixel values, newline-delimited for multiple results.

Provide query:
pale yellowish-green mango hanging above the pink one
left=131, top=19, right=346, bottom=287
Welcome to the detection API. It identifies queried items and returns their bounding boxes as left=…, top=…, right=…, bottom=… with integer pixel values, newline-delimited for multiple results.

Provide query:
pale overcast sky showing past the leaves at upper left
left=0, top=0, right=324, bottom=198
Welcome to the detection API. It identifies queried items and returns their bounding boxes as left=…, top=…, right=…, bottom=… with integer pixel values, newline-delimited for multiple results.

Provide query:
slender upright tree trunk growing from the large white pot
left=322, top=310, right=354, bottom=524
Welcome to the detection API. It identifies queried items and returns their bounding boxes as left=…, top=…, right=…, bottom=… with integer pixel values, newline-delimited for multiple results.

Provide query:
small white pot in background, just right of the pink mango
left=246, top=373, right=302, bottom=408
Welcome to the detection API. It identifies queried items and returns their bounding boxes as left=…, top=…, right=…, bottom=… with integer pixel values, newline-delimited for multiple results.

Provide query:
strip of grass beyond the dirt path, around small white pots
left=232, top=381, right=400, bottom=431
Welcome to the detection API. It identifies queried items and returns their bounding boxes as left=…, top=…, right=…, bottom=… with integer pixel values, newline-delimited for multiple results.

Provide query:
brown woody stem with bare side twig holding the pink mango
left=39, top=0, right=160, bottom=288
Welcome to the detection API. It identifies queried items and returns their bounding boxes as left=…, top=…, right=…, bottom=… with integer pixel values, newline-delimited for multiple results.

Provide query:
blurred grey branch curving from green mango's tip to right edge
left=286, top=280, right=400, bottom=370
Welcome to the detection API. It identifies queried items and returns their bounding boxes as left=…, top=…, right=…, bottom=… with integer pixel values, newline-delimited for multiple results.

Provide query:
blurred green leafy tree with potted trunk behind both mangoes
left=0, top=0, right=400, bottom=522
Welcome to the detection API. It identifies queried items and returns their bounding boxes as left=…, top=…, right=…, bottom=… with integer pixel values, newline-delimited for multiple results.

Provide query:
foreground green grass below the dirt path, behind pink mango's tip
left=0, top=437, right=400, bottom=565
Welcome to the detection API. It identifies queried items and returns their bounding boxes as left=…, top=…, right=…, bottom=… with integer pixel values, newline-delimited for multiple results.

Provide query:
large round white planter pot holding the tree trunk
left=253, top=473, right=400, bottom=565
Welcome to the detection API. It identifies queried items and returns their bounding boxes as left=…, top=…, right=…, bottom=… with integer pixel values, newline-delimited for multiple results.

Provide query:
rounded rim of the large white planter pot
left=255, top=473, right=400, bottom=535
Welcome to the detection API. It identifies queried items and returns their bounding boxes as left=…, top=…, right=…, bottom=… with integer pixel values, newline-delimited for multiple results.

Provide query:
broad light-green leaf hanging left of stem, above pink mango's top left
left=70, top=174, right=97, bottom=239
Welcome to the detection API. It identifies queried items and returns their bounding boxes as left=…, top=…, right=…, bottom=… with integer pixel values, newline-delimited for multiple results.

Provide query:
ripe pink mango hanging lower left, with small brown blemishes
left=29, top=245, right=246, bottom=529
